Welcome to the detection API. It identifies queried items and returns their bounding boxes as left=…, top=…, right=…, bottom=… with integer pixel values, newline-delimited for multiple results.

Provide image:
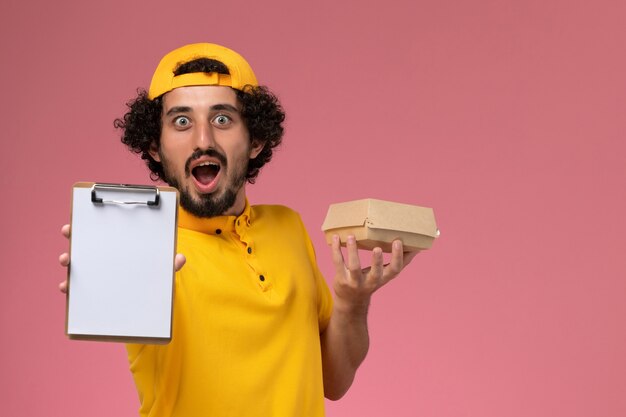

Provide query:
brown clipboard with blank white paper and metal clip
left=66, top=183, right=178, bottom=344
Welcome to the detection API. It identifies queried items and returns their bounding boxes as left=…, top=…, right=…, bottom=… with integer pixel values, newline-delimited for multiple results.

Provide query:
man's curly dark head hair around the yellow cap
left=113, top=58, right=285, bottom=183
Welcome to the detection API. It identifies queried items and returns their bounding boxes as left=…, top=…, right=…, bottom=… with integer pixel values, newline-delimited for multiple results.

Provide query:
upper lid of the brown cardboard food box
left=322, top=198, right=439, bottom=237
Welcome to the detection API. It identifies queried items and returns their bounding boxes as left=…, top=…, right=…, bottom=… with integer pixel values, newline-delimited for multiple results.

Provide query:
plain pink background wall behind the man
left=0, top=0, right=626, bottom=417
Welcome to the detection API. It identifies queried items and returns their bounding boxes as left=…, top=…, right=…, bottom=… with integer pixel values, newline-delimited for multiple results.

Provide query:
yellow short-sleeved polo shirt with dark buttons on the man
left=127, top=202, right=332, bottom=417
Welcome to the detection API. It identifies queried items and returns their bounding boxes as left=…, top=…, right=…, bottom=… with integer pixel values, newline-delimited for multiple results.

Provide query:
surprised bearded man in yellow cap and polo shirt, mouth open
left=60, top=44, right=413, bottom=416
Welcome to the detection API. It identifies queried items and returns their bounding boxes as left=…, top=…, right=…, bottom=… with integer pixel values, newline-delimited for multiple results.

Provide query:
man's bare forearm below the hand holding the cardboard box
left=321, top=300, right=369, bottom=400
